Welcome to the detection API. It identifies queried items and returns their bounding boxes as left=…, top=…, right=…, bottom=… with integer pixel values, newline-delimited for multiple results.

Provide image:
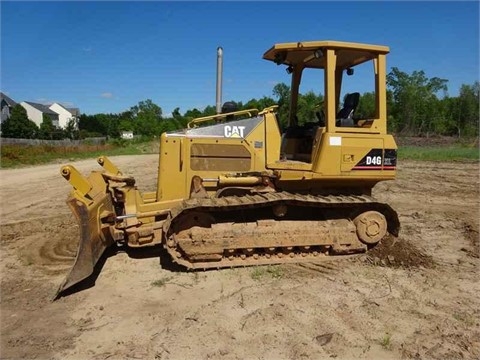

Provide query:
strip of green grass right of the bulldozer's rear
left=398, top=145, right=480, bottom=161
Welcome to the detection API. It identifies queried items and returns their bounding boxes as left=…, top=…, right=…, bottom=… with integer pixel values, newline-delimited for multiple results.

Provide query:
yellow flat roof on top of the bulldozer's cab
left=263, top=40, right=390, bottom=68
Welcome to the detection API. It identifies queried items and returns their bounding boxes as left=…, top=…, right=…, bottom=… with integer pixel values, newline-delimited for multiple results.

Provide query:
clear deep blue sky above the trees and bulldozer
left=0, top=0, right=479, bottom=115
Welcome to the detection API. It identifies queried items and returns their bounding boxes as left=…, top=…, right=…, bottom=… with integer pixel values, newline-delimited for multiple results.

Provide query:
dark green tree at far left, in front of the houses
left=1, top=104, right=38, bottom=139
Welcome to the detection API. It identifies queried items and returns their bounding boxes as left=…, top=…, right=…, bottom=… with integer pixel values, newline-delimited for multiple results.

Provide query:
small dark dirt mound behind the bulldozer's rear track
left=362, top=236, right=435, bottom=268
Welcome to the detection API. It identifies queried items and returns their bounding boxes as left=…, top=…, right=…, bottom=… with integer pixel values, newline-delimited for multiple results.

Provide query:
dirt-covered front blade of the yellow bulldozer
left=54, top=193, right=113, bottom=299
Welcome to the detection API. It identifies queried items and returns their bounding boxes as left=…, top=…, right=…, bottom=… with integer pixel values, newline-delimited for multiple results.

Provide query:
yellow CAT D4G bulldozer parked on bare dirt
left=59, top=41, right=400, bottom=294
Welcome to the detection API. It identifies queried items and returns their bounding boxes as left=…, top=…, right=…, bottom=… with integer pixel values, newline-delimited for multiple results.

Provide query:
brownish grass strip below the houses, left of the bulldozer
left=0, top=141, right=158, bottom=168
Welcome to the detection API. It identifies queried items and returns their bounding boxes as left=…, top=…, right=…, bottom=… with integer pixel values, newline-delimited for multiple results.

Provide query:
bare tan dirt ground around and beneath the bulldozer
left=0, top=155, right=480, bottom=359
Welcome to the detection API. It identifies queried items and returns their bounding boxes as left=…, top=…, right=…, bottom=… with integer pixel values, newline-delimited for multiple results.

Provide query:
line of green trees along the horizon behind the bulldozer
left=1, top=67, right=480, bottom=139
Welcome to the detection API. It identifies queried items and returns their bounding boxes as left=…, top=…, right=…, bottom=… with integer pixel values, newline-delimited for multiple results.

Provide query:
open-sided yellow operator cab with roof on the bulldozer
left=263, top=41, right=389, bottom=163
